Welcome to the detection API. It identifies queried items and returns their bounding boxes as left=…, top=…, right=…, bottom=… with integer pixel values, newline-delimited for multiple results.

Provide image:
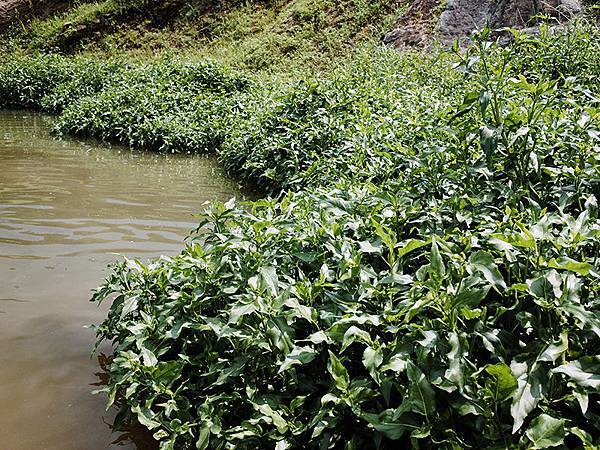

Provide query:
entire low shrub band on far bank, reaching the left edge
left=0, top=55, right=249, bottom=153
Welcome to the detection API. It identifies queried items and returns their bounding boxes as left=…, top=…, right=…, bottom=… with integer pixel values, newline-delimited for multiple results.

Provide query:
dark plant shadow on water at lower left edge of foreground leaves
left=91, top=353, right=159, bottom=450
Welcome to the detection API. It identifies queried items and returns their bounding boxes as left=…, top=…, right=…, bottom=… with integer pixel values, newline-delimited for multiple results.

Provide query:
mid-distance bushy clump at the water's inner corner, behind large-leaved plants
left=220, top=49, right=464, bottom=192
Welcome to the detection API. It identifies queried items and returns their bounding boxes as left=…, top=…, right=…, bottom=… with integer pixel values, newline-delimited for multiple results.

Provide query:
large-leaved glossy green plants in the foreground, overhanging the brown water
left=96, top=188, right=600, bottom=448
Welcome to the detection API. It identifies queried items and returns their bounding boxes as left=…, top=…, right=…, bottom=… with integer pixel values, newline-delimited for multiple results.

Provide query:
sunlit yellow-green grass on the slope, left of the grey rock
left=5, top=0, right=402, bottom=75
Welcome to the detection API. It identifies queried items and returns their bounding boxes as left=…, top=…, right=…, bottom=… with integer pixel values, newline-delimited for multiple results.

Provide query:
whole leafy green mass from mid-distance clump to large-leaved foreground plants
left=88, top=26, right=600, bottom=450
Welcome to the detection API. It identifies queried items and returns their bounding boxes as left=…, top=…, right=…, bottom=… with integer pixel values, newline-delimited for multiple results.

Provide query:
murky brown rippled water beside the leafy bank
left=0, top=111, right=244, bottom=450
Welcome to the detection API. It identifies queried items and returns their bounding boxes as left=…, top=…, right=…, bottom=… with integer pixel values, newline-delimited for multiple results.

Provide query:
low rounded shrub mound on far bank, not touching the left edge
left=55, top=60, right=249, bottom=153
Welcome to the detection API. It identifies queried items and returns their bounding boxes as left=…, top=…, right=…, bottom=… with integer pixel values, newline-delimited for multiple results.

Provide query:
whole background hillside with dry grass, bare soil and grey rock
left=0, top=0, right=597, bottom=72
